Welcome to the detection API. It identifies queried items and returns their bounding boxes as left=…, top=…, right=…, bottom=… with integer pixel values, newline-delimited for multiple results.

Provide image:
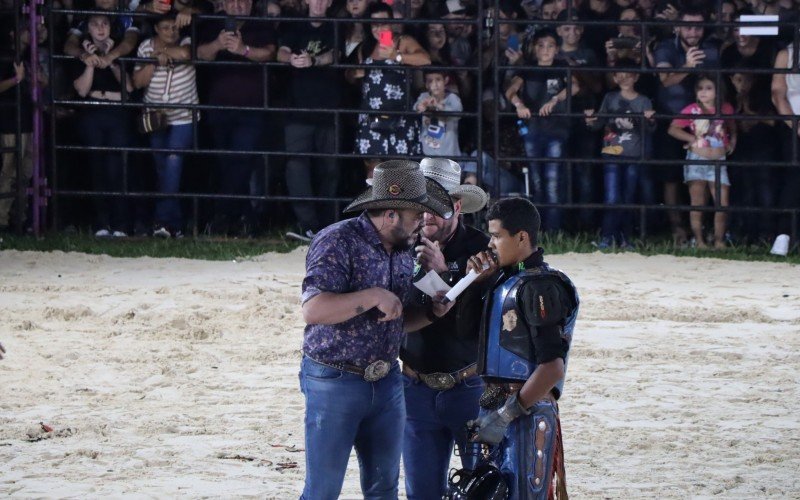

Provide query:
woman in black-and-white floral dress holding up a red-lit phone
left=347, top=2, right=431, bottom=179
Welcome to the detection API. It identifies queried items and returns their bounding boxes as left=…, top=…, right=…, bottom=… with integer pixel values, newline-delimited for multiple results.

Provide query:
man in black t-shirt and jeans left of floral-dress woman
left=278, top=0, right=342, bottom=241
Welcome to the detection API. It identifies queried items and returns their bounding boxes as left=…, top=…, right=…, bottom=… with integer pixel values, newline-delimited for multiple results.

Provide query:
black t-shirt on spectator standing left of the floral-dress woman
left=280, top=22, right=343, bottom=121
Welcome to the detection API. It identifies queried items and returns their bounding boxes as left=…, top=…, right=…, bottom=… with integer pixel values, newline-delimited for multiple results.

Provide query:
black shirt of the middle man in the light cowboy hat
left=400, top=222, right=489, bottom=373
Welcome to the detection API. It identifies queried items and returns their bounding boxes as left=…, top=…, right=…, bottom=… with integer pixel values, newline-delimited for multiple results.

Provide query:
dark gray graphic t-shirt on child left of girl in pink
left=592, top=91, right=655, bottom=157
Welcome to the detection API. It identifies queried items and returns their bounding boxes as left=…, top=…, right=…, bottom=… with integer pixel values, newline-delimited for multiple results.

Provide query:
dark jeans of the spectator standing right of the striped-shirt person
left=208, top=110, right=265, bottom=222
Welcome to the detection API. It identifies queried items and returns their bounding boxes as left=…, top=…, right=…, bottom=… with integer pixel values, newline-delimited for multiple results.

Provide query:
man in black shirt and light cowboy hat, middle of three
left=400, top=158, right=489, bottom=499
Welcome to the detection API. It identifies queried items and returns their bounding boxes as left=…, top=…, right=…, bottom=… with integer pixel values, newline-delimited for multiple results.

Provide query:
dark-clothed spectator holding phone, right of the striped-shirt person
left=197, top=0, right=276, bottom=236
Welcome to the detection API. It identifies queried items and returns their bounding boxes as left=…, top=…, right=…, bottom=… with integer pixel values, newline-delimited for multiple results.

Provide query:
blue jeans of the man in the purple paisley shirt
left=300, top=357, right=406, bottom=500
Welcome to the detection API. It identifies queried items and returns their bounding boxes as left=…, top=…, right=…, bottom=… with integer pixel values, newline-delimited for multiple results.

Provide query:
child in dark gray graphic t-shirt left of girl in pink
left=586, top=59, right=655, bottom=249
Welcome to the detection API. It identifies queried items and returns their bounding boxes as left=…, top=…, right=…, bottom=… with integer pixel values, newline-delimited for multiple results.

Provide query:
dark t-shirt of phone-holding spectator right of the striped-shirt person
left=198, top=19, right=275, bottom=107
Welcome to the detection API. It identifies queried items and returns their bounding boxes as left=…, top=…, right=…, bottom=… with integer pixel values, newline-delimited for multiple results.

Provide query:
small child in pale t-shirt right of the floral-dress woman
left=414, top=70, right=464, bottom=158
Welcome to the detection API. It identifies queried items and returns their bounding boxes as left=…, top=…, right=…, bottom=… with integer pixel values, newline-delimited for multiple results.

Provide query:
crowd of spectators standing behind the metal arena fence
left=0, top=0, right=800, bottom=248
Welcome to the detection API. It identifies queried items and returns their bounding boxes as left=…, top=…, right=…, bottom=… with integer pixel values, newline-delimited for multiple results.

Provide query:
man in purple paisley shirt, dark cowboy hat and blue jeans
left=300, top=160, right=453, bottom=500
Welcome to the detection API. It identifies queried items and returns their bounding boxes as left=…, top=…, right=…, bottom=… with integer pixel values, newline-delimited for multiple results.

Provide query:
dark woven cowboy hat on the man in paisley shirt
left=344, top=160, right=453, bottom=219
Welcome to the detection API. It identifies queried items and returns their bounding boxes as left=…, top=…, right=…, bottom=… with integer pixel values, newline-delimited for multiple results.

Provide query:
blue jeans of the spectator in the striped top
left=150, top=123, right=192, bottom=229
